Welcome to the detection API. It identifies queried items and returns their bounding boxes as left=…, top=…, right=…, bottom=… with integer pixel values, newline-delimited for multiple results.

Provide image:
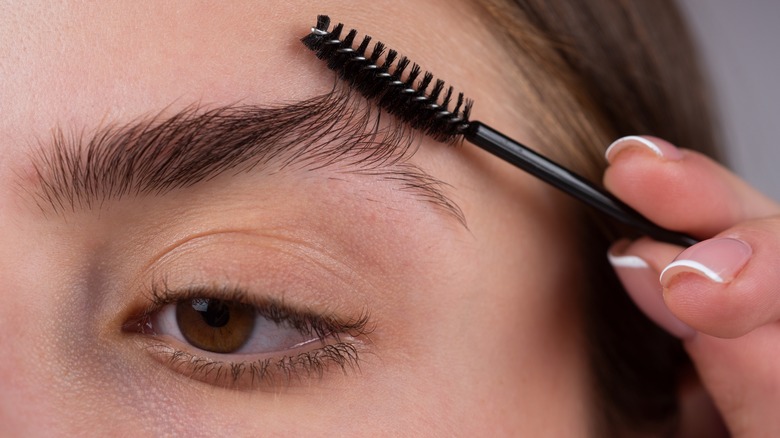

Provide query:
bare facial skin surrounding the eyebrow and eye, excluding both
left=0, top=1, right=591, bottom=436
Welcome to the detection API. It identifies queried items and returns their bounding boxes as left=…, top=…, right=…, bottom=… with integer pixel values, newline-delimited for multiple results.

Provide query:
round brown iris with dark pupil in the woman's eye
left=176, top=298, right=256, bottom=353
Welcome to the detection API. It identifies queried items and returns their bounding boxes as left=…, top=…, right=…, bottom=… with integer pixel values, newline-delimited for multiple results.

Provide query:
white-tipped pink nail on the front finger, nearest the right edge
left=661, top=237, right=753, bottom=287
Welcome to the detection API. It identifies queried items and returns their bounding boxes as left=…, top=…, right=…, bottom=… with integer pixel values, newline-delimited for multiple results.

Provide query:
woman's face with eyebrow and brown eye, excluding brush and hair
left=0, top=0, right=590, bottom=436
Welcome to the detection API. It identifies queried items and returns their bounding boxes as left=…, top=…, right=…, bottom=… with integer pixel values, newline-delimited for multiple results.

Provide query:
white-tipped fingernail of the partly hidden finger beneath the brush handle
left=607, top=248, right=696, bottom=339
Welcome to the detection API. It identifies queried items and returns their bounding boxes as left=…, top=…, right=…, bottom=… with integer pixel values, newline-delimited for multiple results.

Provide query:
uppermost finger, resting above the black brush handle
left=604, top=136, right=780, bottom=237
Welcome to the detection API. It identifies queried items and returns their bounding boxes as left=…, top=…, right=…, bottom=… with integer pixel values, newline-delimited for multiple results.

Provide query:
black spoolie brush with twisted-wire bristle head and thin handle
left=301, top=15, right=697, bottom=246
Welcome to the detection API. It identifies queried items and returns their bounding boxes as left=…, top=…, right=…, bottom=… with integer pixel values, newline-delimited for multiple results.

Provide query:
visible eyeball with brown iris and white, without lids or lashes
left=149, top=298, right=327, bottom=354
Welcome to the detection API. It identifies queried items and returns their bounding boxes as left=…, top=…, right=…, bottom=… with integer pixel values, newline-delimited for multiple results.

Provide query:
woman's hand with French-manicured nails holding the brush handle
left=604, top=137, right=780, bottom=437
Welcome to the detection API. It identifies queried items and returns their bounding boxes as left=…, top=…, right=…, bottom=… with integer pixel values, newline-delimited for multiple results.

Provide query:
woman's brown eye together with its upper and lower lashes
left=122, top=285, right=373, bottom=388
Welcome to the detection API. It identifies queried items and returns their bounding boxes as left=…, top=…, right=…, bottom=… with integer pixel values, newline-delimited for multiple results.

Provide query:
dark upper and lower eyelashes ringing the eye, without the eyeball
left=123, top=282, right=373, bottom=388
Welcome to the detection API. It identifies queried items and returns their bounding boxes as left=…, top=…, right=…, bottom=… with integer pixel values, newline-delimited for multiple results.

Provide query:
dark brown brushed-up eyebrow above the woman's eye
left=24, top=86, right=465, bottom=225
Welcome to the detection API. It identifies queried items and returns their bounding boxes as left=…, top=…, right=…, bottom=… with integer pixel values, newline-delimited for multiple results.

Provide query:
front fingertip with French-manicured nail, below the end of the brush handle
left=660, top=217, right=780, bottom=338
